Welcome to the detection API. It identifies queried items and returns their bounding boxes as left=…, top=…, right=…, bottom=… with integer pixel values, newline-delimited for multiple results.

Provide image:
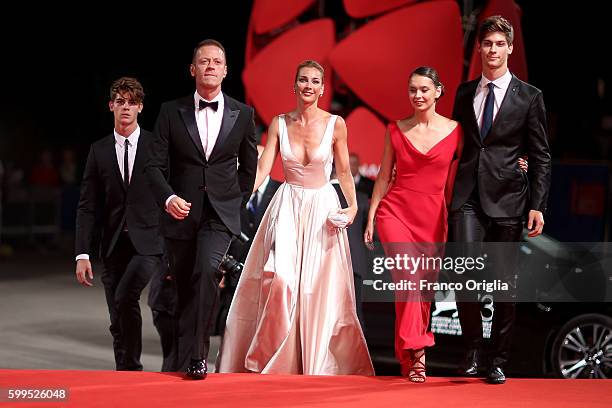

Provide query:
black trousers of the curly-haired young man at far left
left=102, top=232, right=161, bottom=371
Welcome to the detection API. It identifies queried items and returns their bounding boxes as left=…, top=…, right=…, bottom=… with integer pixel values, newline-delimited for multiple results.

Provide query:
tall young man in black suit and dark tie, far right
left=449, top=16, right=551, bottom=384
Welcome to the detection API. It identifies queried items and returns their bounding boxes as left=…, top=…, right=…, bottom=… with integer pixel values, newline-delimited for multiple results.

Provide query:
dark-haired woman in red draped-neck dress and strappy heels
left=364, top=67, right=527, bottom=382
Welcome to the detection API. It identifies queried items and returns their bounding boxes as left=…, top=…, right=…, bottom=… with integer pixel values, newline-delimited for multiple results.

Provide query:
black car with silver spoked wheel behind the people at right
left=363, top=236, right=612, bottom=378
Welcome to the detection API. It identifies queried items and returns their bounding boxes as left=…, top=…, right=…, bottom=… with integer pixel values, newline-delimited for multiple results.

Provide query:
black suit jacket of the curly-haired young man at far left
left=75, top=129, right=163, bottom=258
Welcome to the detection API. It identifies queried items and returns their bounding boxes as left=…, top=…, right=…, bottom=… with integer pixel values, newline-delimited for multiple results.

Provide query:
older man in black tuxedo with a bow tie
left=146, top=40, right=257, bottom=379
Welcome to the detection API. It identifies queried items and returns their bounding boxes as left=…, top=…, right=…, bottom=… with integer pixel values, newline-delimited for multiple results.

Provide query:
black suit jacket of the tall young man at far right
left=451, top=76, right=551, bottom=217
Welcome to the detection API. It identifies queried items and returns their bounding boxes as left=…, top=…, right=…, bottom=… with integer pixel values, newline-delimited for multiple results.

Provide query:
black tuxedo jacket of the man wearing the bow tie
left=146, top=94, right=257, bottom=239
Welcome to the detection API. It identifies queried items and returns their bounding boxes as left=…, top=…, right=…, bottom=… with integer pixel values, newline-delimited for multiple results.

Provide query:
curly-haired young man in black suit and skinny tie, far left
left=75, top=77, right=163, bottom=370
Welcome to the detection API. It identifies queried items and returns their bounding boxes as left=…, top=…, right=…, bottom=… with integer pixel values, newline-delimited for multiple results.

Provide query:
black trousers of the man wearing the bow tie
left=166, top=198, right=232, bottom=371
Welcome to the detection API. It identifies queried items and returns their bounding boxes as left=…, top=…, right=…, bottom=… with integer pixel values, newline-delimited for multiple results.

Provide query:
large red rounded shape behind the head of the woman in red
left=329, top=1, right=463, bottom=120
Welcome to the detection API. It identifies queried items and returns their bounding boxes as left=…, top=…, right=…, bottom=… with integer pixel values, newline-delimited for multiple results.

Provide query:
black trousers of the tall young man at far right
left=448, top=192, right=523, bottom=366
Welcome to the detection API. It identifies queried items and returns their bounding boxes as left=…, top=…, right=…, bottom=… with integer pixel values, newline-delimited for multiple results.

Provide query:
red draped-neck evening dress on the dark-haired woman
left=376, top=122, right=462, bottom=370
